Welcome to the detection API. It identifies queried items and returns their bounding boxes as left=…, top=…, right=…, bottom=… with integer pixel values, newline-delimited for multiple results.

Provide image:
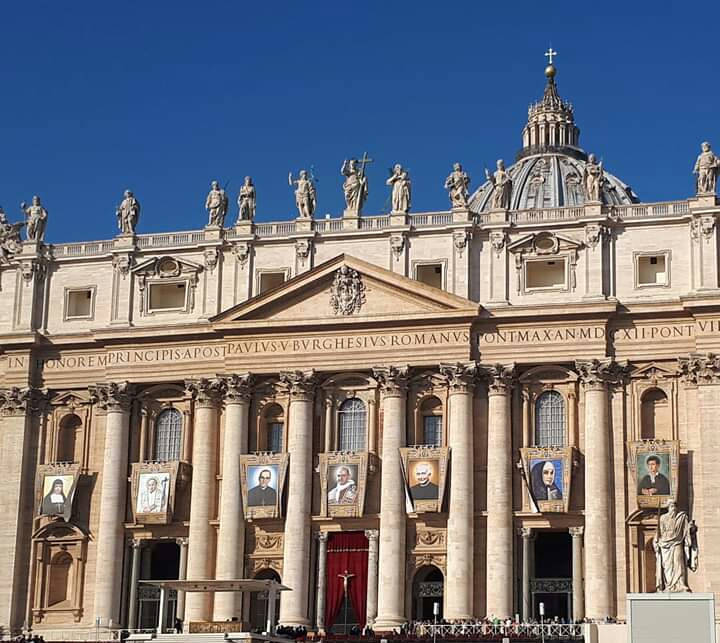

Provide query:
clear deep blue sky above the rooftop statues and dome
left=0, top=0, right=720, bottom=243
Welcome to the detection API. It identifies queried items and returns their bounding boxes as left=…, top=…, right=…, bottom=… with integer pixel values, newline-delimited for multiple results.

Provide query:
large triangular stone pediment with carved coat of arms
left=210, top=254, right=478, bottom=326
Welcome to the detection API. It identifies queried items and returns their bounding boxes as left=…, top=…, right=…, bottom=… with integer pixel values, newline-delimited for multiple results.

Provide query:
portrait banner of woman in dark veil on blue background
left=520, top=447, right=573, bottom=513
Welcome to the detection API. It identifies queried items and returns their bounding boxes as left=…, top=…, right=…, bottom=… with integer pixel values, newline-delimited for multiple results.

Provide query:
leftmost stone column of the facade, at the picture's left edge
left=0, top=387, right=39, bottom=634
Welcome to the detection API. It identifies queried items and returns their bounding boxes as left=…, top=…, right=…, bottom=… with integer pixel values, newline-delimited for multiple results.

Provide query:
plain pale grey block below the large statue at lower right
left=627, top=592, right=716, bottom=643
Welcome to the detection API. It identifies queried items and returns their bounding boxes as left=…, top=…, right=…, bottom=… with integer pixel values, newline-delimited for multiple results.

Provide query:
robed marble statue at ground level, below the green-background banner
left=653, top=500, right=697, bottom=592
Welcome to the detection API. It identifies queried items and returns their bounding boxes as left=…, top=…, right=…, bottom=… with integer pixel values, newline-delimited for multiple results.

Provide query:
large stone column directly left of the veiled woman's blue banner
left=480, top=365, right=514, bottom=618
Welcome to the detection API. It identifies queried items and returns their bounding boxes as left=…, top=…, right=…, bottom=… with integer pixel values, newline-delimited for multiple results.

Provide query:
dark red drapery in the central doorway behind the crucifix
left=325, top=531, right=368, bottom=630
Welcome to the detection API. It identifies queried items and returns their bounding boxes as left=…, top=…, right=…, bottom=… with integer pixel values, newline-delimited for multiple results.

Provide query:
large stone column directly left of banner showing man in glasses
left=214, top=374, right=252, bottom=621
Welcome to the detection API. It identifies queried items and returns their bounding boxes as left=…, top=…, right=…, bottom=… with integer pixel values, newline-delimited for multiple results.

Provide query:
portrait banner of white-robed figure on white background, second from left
left=131, top=462, right=179, bottom=525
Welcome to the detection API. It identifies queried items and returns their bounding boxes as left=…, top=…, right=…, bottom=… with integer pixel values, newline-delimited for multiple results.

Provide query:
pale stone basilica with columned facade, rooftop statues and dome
left=0, top=65, right=720, bottom=639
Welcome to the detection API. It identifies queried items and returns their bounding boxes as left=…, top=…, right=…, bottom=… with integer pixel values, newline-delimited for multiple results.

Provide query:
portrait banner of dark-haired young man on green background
left=628, top=440, right=680, bottom=509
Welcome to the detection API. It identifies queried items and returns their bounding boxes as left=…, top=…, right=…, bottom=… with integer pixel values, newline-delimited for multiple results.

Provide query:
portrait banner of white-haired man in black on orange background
left=400, top=446, right=450, bottom=513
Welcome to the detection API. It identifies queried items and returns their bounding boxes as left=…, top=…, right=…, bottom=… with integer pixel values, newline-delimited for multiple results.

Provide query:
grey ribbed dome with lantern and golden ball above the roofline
left=469, top=59, right=639, bottom=213
